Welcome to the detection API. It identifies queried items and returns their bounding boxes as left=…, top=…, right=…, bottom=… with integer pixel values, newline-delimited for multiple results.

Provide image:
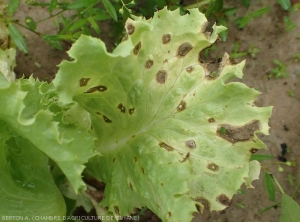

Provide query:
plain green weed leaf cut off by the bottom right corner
left=280, top=194, right=300, bottom=222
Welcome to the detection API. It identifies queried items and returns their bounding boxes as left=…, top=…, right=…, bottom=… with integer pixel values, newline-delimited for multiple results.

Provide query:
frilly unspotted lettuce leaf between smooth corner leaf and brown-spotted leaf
left=0, top=77, right=96, bottom=192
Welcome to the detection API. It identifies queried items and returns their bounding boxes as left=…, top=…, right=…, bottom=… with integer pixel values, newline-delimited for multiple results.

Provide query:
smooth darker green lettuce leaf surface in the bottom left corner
left=0, top=121, right=66, bottom=222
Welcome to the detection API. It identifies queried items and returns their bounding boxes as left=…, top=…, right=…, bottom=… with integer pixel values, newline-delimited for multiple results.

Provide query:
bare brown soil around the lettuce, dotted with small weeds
left=15, top=0, right=300, bottom=222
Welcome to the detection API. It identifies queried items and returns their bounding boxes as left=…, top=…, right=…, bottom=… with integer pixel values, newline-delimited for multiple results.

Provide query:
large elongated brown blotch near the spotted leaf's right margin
left=217, top=120, right=260, bottom=143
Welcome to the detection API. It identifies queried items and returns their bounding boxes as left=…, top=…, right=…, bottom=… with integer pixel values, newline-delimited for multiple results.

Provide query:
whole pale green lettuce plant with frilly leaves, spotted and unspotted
left=0, top=9, right=272, bottom=221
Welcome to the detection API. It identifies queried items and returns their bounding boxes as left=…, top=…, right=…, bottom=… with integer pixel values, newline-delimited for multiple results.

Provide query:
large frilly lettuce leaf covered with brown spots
left=53, top=8, right=271, bottom=222
